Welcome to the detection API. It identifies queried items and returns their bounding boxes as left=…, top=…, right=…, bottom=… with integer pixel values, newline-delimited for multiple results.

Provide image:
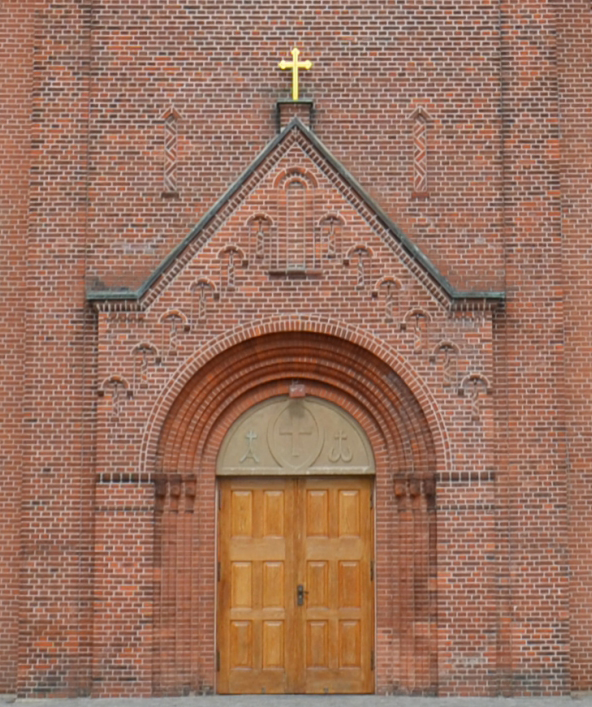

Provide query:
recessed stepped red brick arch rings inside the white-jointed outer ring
left=155, top=332, right=437, bottom=476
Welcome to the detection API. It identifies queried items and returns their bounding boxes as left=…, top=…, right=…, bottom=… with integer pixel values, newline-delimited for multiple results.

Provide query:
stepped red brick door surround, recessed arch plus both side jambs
left=150, top=323, right=444, bottom=694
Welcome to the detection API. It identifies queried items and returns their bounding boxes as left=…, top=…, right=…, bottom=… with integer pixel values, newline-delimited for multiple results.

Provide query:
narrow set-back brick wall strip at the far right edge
left=558, top=0, right=592, bottom=691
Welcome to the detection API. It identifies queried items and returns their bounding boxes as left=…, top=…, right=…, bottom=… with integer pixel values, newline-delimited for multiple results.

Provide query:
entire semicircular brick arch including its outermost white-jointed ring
left=140, top=318, right=449, bottom=475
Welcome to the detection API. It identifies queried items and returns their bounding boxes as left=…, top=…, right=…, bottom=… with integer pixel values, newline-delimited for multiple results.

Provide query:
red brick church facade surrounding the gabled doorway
left=0, top=0, right=592, bottom=695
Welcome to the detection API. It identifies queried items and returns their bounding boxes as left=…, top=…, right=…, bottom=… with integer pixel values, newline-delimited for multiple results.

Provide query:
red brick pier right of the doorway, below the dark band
left=437, top=473, right=498, bottom=696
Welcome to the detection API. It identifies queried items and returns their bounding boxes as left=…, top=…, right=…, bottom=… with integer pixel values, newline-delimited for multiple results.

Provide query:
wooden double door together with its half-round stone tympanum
left=217, top=398, right=374, bottom=694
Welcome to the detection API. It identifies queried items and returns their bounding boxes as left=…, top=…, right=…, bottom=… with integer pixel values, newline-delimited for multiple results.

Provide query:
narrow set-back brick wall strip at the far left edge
left=0, top=2, right=33, bottom=693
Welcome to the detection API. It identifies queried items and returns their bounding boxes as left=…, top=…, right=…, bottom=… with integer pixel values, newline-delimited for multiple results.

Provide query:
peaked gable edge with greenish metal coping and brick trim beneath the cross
left=87, top=118, right=504, bottom=309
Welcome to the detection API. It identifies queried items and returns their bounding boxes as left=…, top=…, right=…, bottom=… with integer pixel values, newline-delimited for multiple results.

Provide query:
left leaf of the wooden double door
left=218, top=479, right=294, bottom=693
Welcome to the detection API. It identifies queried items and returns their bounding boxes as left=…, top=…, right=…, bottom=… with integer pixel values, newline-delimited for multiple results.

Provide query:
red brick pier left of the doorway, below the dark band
left=93, top=481, right=154, bottom=697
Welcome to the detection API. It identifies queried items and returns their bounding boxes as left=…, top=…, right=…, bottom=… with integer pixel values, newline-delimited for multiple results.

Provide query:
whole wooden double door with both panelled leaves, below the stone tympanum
left=217, top=477, right=374, bottom=694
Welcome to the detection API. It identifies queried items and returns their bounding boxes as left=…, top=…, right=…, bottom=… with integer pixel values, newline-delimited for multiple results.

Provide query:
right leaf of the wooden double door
left=298, top=477, right=373, bottom=693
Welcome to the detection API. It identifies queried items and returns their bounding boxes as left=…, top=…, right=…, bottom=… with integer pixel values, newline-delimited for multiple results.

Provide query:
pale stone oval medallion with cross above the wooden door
left=268, top=399, right=323, bottom=470
